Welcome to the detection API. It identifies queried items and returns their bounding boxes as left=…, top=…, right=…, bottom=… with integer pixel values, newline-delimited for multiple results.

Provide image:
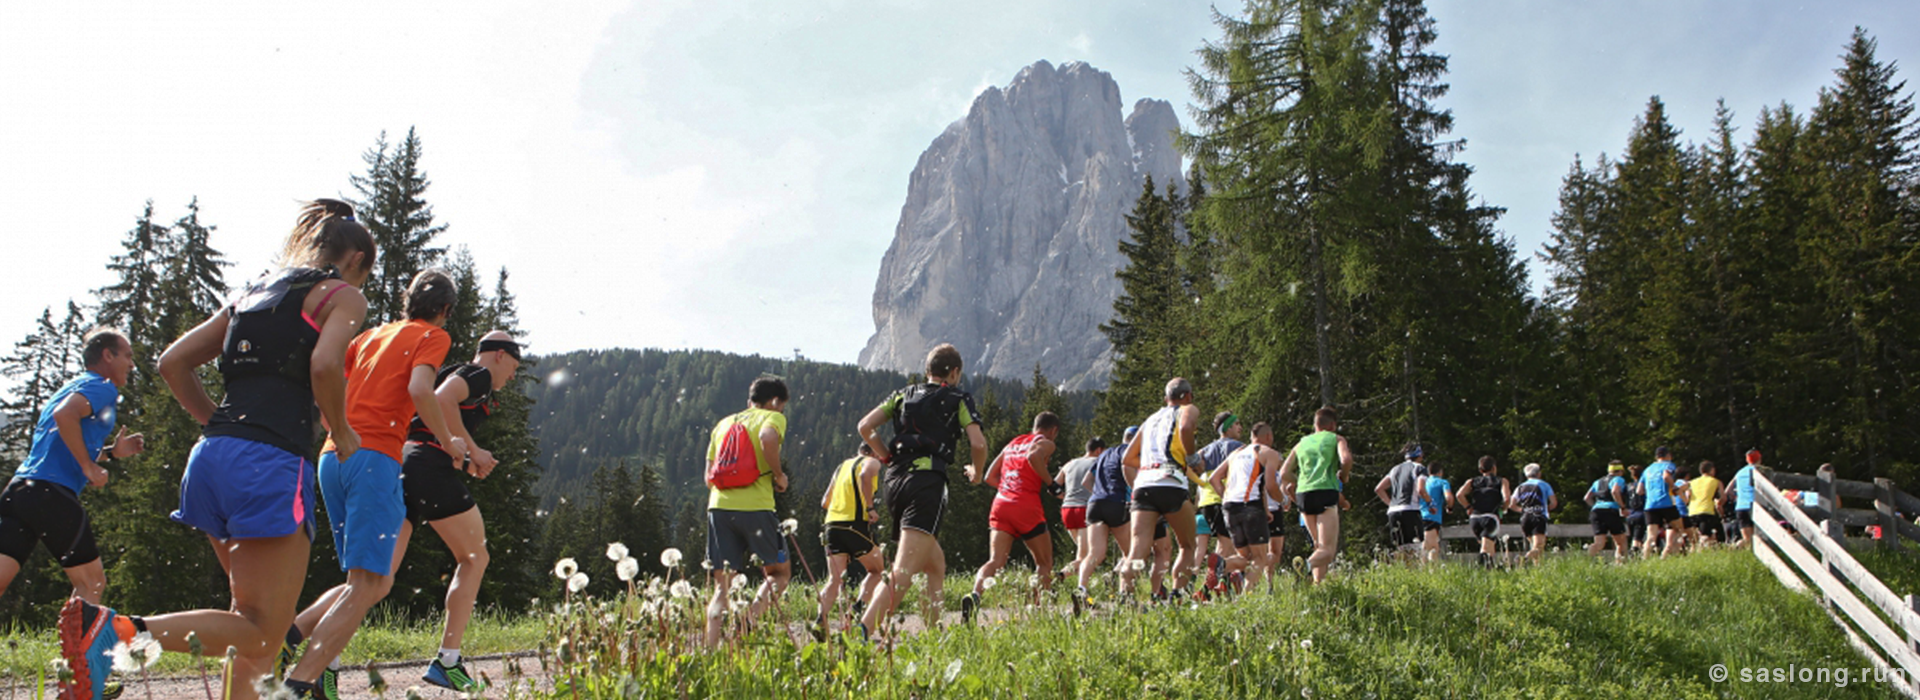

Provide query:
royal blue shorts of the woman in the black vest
left=171, top=435, right=315, bottom=539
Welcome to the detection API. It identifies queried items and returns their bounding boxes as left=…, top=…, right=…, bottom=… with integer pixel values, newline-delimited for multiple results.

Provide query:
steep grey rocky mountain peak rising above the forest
left=860, top=61, right=1185, bottom=389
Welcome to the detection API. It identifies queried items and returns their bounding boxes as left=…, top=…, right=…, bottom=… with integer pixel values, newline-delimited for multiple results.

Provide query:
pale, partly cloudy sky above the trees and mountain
left=0, top=0, right=1920, bottom=362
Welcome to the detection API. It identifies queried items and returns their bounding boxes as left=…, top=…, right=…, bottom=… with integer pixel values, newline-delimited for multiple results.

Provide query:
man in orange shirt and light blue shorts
left=286, top=270, right=467, bottom=700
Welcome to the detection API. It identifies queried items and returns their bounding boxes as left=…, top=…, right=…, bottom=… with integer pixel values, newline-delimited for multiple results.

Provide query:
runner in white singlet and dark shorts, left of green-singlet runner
left=1210, top=422, right=1283, bottom=593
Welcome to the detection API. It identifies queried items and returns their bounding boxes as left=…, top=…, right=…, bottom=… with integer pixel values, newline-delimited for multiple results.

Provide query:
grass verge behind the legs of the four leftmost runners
left=0, top=608, right=543, bottom=683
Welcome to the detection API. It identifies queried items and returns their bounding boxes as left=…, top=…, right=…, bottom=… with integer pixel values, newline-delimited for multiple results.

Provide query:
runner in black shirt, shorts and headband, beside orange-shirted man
left=397, top=330, right=520, bottom=692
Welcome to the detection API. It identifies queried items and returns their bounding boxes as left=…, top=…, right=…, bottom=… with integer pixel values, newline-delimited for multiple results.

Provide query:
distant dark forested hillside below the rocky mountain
left=530, top=349, right=1094, bottom=566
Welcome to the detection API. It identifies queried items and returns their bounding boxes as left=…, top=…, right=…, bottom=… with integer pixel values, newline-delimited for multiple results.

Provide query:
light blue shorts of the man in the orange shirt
left=321, top=449, right=407, bottom=575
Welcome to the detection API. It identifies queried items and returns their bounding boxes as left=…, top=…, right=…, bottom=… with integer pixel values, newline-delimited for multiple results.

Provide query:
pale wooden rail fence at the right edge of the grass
left=1753, top=472, right=1920, bottom=700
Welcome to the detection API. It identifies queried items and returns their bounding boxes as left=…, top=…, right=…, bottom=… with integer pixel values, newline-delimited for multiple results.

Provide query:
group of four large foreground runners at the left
left=0, top=199, right=520, bottom=700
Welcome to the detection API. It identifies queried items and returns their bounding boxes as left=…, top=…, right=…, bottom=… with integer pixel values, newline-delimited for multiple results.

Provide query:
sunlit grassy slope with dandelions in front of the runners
left=549, top=550, right=1889, bottom=698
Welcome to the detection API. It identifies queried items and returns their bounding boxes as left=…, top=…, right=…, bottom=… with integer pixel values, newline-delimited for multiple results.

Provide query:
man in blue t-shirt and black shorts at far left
left=0, top=328, right=146, bottom=604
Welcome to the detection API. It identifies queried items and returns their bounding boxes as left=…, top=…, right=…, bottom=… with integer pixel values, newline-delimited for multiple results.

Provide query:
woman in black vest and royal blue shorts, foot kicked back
left=60, top=199, right=374, bottom=700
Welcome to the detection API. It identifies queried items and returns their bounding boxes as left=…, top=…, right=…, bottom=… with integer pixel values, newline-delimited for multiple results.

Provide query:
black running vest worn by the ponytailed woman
left=202, top=267, right=346, bottom=456
